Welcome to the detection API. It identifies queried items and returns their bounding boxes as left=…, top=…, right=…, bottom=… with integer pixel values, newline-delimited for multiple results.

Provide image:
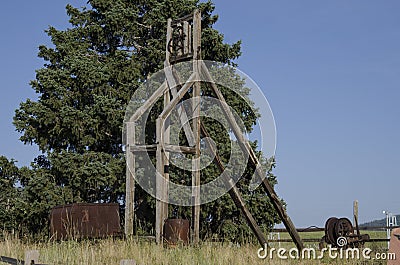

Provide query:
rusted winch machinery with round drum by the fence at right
left=321, top=217, right=370, bottom=248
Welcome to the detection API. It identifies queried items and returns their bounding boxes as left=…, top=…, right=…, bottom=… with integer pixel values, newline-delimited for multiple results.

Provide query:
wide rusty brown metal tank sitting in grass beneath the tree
left=50, top=203, right=121, bottom=240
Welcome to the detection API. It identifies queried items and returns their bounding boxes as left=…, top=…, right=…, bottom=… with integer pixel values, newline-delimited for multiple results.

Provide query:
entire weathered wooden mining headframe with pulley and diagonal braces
left=125, top=10, right=303, bottom=249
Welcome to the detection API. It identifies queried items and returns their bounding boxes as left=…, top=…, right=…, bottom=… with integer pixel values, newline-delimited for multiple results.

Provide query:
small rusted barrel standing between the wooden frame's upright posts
left=164, top=219, right=189, bottom=246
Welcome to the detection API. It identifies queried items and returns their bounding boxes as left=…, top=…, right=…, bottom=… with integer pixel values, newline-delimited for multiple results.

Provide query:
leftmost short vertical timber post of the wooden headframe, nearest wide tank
left=125, top=122, right=135, bottom=237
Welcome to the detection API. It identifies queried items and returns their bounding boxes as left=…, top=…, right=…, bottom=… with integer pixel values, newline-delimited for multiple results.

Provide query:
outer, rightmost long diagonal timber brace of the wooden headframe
left=201, top=62, right=304, bottom=250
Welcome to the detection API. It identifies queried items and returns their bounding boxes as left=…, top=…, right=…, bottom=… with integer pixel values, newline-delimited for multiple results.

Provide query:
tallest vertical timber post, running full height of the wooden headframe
left=192, top=10, right=201, bottom=244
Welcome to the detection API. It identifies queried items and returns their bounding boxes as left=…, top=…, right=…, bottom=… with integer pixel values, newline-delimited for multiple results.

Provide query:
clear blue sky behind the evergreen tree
left=0, top=0, right=400, bottom=227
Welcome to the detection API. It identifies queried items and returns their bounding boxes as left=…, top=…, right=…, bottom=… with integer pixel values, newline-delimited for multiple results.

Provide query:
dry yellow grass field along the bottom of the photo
left=0, top=232, right=392, bottom=265
